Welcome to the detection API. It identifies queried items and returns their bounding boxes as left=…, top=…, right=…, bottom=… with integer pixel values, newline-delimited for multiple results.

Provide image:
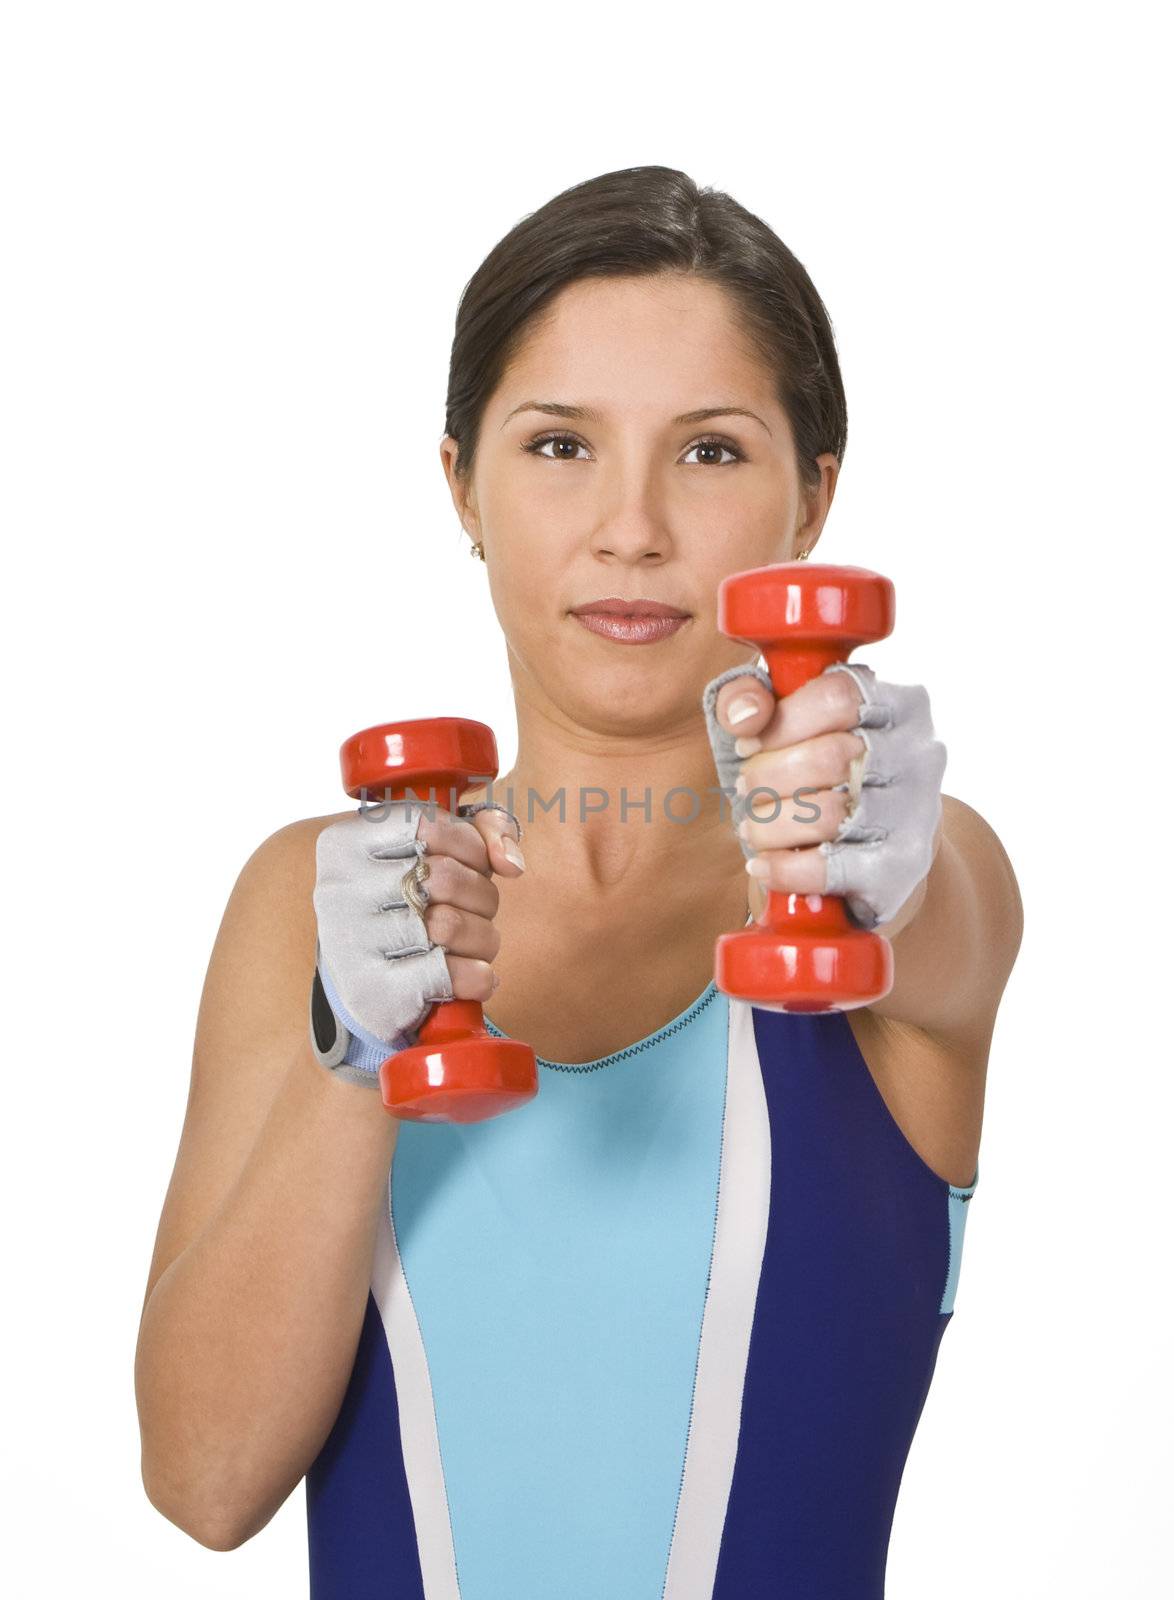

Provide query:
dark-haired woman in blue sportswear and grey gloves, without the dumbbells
left=136, top=166, right=1020, bottom=1600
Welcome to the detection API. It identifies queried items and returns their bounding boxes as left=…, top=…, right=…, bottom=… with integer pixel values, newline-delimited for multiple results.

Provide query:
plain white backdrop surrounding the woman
left=0, top=0, right=1174, bottom=1600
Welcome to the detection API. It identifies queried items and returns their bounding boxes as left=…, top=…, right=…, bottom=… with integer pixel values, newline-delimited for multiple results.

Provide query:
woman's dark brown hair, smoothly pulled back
left=445, top=166, right=848, bottom=486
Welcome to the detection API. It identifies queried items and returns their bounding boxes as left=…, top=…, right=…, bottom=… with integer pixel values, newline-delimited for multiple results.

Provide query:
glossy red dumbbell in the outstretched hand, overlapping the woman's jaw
left=715, top=562, right=896, bottom=1011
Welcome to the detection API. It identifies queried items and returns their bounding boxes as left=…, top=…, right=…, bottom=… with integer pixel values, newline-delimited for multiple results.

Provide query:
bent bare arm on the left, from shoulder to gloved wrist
left=134, top=818, right=400, bottom=1550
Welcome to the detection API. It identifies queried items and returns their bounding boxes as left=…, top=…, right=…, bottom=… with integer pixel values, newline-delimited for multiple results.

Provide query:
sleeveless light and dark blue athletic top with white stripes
left=305, top=982, right=977, bottom=1600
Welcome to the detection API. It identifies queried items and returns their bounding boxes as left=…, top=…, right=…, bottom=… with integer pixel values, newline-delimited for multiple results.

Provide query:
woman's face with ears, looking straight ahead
left=441, top=274, right=838, bottom=734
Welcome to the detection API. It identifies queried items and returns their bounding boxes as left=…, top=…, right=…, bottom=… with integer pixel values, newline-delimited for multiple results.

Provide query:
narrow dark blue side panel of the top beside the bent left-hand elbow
left=305, top=1293, right=424, bottom=1600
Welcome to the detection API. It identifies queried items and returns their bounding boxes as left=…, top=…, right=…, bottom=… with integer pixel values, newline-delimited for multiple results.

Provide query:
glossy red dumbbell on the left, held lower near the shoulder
left=339, top=717, right=537, bottom=1122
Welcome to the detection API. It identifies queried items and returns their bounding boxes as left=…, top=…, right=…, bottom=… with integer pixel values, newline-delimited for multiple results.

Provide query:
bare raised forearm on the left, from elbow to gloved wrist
left=136, top=1042, right=398, bottom=1547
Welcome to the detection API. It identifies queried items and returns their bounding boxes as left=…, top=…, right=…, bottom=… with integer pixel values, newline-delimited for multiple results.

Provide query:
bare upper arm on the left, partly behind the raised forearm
left=147, top=813, right=347, bottom=1296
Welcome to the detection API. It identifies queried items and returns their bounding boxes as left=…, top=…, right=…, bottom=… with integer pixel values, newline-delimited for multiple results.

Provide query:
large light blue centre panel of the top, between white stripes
left=392, top=984, right=729, bottom=1600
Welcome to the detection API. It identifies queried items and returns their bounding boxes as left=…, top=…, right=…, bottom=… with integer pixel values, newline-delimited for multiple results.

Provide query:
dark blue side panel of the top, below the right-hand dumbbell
left=713, top=1010, right=950, bottom=1600
